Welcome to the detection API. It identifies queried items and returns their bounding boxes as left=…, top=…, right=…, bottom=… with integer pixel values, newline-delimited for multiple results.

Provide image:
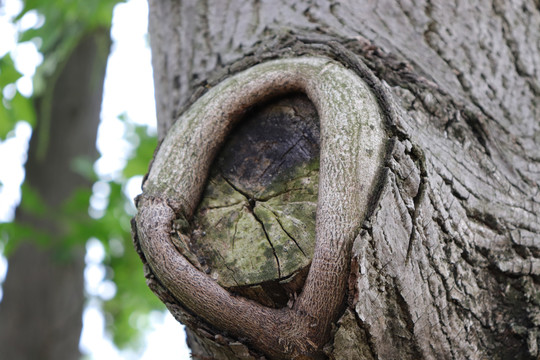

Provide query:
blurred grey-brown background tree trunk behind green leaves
left=0, top=30, right=110, bottom=360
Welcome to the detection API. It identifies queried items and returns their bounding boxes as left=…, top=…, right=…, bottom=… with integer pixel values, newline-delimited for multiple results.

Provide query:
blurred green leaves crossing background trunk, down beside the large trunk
left=0, top=116, right=160, bottom=349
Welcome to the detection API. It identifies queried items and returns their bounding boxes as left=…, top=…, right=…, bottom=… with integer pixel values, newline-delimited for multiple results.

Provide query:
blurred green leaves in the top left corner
left=0, top=0, right=121, bottom=140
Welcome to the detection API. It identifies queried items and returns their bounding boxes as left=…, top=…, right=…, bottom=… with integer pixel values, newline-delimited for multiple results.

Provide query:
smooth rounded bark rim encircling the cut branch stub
left=136, top=57, right=386, bottom=358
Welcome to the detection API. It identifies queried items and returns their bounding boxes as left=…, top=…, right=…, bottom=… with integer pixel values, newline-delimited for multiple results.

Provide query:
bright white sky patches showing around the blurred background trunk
left=0, top=0, right=189, bottom=360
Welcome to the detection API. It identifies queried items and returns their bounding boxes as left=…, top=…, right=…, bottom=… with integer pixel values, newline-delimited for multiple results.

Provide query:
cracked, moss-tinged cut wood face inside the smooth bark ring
left=184, top=94, right=320, bottom=307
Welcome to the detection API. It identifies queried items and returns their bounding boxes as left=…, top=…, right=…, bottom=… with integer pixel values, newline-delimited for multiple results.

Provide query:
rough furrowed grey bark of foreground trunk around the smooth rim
left=139, top=0, right=540, bottom=359
